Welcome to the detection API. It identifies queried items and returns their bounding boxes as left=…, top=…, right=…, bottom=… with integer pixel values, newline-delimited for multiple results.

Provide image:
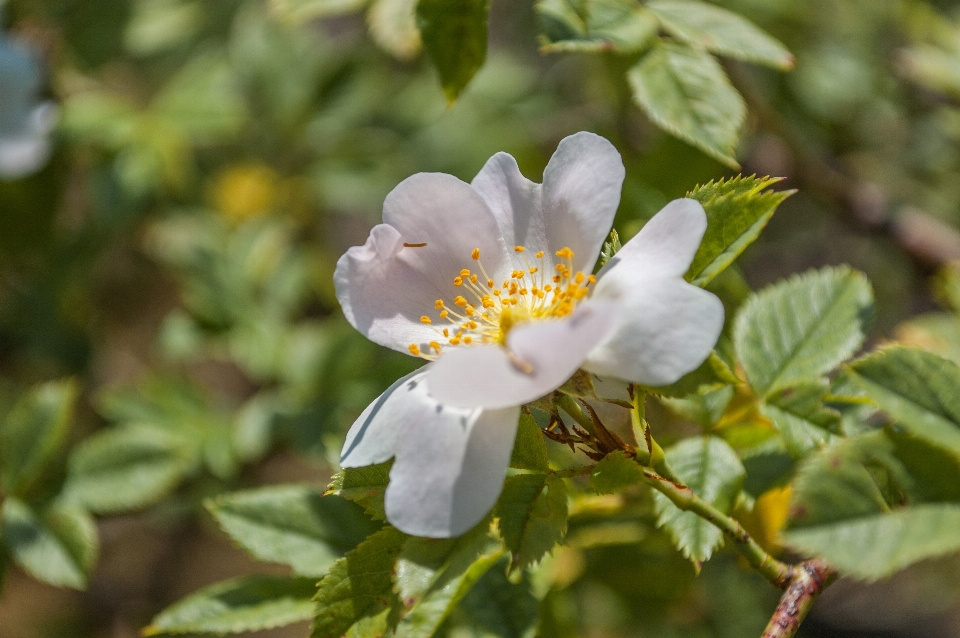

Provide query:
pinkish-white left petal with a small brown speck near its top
left=333, top=173, right=512, bottom=352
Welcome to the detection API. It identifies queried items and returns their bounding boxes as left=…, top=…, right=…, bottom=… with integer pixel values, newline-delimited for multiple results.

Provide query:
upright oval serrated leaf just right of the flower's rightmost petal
left=733, top=266, right=873, bottom=396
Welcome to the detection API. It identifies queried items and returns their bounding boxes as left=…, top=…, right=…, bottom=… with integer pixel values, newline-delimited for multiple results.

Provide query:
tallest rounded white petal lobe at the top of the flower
left=543, top=132, right=624, bottom=273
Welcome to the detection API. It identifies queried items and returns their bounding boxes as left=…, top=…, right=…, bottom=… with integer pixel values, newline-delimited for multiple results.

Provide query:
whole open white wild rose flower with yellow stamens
left=334, top=132, right=724, bottom=538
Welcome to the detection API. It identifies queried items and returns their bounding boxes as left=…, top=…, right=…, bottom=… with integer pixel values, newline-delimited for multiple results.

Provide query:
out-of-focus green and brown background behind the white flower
left=0, top=0, right=960, bottom=638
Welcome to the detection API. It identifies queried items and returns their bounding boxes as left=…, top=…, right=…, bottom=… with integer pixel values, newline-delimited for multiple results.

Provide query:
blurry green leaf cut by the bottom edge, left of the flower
left=143, top=576, right=317, bottom=636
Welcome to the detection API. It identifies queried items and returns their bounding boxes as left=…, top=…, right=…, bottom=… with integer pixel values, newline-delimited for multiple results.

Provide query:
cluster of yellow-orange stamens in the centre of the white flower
left=409, top=246, right=596, bottom=359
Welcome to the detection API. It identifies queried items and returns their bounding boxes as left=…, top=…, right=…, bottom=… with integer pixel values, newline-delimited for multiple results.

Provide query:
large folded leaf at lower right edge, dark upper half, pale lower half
left=784, top=431, right=960, bottom=580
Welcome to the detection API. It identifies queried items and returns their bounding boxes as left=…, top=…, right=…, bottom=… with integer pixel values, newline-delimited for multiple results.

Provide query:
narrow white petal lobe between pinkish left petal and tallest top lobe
left=470, top=153, right=548, bottom=268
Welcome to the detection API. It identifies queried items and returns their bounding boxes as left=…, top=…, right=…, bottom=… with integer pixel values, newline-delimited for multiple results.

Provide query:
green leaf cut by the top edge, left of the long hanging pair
left=534, top=0, right=659, bottom=53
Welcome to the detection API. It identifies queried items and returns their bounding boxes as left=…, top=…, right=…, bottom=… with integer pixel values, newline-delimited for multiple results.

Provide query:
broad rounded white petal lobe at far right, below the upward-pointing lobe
left=584, top=278, right=723, bottom=386
